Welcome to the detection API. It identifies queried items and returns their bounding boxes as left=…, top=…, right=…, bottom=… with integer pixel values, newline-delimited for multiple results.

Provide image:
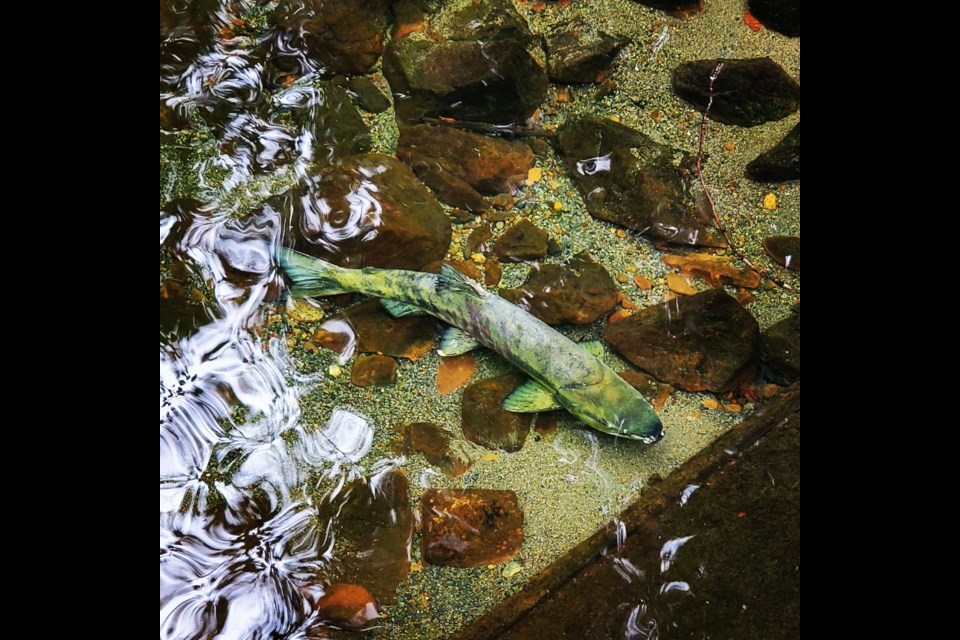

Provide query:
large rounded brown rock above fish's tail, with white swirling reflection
left=280, top=153, right=452, bottom=269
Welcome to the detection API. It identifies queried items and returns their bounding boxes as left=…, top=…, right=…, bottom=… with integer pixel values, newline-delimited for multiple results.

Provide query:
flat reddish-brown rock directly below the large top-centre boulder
left=397, top=125, right=533, bottom=211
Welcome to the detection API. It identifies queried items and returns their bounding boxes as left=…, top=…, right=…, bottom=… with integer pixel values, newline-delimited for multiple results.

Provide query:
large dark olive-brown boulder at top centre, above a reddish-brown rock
left=383, top=0, right=548, bottom=124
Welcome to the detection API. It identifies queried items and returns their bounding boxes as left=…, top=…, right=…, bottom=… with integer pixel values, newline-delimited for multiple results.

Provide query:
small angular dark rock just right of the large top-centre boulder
left=543, top=19, right=628, bottom=83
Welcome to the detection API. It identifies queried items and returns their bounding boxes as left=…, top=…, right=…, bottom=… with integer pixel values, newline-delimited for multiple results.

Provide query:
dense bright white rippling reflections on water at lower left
left=160, top=192, right=373, bottom=639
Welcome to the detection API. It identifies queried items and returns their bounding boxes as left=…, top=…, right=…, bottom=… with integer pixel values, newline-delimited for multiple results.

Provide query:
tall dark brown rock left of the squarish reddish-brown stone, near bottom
left=318, top=470, right=413, bottom=604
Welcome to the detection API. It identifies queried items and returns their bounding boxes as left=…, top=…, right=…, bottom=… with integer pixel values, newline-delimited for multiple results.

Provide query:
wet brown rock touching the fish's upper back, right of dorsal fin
left=500, top=252, right=617, bottom=325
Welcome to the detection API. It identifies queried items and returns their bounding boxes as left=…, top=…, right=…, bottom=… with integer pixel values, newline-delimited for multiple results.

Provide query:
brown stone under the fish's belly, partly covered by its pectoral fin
left=460, top=373, right=533, bottom=452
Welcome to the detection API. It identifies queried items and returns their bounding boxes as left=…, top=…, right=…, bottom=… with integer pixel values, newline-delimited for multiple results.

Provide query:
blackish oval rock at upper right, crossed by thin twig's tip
left=673, top=58, right=800, bottom=127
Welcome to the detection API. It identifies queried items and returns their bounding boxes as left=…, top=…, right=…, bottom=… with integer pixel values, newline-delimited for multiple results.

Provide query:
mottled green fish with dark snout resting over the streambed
left=280, top=249, right=663, bottom=444
